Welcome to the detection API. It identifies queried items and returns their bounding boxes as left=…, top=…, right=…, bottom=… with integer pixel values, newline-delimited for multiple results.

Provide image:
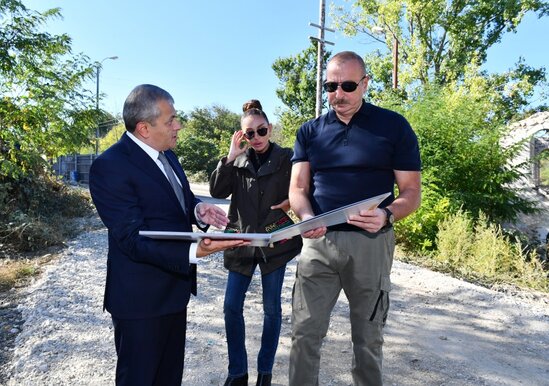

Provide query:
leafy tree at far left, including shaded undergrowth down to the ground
left=0, top=0, right=96, bottom=253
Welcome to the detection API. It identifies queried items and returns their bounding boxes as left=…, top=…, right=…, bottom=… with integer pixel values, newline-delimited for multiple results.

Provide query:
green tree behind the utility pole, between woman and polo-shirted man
left=272, top=43, right=331, bottom=146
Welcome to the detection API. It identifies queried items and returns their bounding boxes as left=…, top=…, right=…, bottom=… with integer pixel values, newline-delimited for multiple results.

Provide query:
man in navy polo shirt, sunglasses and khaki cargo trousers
left=289, top=51, right=421, bottom=386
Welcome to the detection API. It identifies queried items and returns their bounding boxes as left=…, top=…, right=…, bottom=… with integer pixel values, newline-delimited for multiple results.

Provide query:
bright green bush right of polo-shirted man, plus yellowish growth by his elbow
left=393, top=85, right=535, bottom=252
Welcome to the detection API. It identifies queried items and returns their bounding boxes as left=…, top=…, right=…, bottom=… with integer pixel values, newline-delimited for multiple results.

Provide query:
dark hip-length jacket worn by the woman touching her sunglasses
left=210, top=143, right=301, bottom=276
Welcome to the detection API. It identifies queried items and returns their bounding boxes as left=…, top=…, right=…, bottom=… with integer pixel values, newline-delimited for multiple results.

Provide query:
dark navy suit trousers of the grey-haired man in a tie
left=112, top=310, right=187, bottom=386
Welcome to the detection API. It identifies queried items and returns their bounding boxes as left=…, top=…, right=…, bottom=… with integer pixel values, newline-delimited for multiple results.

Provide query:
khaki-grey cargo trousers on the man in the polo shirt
left=289, top=228, right=395, bottom=386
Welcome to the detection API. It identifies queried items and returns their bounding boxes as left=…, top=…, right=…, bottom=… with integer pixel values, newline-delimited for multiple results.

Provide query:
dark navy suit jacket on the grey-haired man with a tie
left=90, top=134, right=206, bottom=319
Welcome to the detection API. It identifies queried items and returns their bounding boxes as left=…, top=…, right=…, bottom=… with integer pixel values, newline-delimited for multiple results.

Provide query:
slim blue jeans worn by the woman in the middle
left=223, top=265, right=286, bottom=377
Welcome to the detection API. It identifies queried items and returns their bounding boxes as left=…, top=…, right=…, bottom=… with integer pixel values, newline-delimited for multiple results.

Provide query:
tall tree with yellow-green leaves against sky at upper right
left=332, top=0, right=549, bottom=85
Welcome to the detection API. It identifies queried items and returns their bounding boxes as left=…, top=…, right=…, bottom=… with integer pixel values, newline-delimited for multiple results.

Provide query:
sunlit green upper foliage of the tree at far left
left=0, top=0, right=96, bottom=182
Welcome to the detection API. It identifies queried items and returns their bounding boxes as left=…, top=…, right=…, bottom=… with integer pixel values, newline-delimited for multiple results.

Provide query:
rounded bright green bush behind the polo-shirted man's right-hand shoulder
left=406, top=87, right=532, bottom=221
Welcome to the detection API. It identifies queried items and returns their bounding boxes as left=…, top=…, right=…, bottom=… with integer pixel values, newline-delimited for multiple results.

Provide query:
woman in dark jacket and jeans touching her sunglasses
left=210, top=99, right=301, bottom=386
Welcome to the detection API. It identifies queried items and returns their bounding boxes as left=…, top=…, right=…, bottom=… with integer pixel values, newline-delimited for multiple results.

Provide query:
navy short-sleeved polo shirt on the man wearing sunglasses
left=292, top=101, right=421, bottom=215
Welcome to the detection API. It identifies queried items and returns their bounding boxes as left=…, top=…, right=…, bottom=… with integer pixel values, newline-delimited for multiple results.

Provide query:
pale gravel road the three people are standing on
left=1, top=187, right=549, bottom=386
